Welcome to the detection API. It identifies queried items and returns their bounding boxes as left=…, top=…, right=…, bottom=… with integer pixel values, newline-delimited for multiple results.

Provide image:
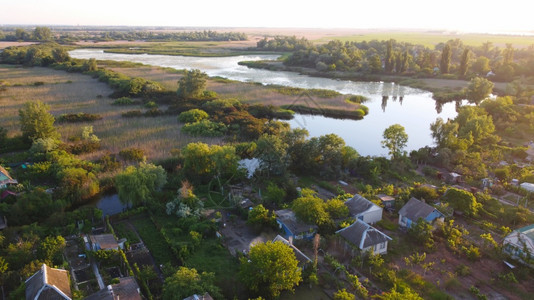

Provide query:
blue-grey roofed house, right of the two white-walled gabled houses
left=399, top=197, right=445, bottom=228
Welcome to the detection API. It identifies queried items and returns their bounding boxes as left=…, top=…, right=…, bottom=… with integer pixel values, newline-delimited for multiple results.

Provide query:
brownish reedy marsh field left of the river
left=0, top=65, right=220, bottom=159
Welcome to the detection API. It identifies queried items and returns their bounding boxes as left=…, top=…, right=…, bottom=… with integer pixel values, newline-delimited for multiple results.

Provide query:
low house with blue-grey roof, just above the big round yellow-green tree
left=274, top=209, right=317, bottom=240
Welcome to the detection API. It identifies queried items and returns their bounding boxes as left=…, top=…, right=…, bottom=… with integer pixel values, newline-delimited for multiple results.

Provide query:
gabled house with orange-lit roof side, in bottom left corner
left=25, top=264, right=72, bottom=300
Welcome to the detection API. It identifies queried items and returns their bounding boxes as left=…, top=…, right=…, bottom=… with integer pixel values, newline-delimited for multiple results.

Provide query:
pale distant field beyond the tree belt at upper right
left=314, top=31, right=534, bottom=48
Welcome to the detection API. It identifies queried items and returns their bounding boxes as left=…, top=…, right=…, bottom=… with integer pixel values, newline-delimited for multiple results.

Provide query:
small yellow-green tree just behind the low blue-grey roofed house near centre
left=292, top=189, right=330, bottom=225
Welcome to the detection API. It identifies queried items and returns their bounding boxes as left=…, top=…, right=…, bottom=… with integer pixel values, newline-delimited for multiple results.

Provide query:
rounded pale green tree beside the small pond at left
left=115, top=163, right=167, bottom=206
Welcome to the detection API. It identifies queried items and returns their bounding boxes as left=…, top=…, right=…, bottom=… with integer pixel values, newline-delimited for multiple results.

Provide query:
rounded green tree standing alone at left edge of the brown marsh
left=19, top=101, right=60, bottom=141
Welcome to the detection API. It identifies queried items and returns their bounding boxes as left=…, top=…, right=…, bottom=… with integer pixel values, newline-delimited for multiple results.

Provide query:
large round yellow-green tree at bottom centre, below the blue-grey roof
left=240, top=242, right=302, bottom=298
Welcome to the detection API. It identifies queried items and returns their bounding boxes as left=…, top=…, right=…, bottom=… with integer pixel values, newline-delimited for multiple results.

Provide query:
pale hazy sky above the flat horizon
left=0, top=0, right=534, bottom=32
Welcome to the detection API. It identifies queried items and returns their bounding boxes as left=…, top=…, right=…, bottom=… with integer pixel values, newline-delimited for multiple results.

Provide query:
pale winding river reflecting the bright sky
left=69, top=49, right=456, bottom=156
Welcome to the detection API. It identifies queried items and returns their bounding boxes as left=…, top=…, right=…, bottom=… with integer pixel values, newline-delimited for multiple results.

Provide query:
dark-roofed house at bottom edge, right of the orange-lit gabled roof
left=85, top=277, right=143, bottom=300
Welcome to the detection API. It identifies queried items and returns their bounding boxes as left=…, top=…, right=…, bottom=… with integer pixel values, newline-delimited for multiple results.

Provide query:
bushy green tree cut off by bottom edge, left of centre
left=163, top=267, right=221, bottom=300
